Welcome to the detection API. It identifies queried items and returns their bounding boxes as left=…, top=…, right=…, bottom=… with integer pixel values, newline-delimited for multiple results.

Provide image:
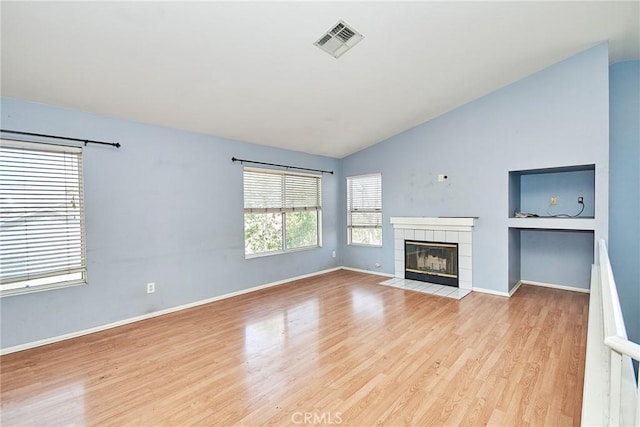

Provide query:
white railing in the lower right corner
left=582, top=240, right=640, bottom=426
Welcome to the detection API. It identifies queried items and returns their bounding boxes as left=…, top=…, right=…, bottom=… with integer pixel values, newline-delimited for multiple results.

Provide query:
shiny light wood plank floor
left=0, top=271, right=588, bottom=426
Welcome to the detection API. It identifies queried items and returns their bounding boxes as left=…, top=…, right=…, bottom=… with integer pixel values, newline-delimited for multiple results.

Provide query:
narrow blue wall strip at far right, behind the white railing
left=609, top=61, right=640, bottom=342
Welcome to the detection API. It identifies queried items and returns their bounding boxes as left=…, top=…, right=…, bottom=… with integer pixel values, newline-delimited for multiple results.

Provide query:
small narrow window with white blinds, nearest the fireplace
left=347, top=173, right=382, bottom=246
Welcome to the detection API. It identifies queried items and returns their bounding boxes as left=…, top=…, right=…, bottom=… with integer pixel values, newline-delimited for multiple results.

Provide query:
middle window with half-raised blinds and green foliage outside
left=244, top=168, right=322, bottom=257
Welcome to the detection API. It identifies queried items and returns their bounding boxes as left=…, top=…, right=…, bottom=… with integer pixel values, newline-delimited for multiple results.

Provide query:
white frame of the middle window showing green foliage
left=242, top=166, right=322, bottom=259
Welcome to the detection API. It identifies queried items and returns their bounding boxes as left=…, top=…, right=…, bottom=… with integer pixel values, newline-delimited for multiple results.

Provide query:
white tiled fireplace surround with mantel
left=391, top=217, right=475, bottom=290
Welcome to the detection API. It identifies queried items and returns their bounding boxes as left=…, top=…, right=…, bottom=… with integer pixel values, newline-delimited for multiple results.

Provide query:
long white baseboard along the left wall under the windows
left=0, top=267, right=344, bottom=356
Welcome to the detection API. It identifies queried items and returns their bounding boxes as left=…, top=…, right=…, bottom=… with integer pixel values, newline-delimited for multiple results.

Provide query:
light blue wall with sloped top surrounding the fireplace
left=343, top=44, right=609, bottom=294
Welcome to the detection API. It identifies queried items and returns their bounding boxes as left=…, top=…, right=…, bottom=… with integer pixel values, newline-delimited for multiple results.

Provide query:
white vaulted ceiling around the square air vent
left=1, top=1, right=640, bottom=158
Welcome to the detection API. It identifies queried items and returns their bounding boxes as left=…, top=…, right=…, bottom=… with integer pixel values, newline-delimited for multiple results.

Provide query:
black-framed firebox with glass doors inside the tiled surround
left=404, top=240, right=458, bottom=288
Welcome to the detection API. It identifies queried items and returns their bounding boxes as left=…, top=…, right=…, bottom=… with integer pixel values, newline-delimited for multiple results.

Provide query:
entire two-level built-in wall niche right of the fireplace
left=507, top=164, right=596, bottom=289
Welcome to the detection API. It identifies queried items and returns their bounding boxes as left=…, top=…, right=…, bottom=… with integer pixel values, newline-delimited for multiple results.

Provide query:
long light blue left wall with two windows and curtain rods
left=0, top=98, right=342, bottom=348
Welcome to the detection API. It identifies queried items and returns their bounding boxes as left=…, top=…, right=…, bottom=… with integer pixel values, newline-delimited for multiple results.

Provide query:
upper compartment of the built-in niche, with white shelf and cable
left=508, top=164, right=595, bottom=222
